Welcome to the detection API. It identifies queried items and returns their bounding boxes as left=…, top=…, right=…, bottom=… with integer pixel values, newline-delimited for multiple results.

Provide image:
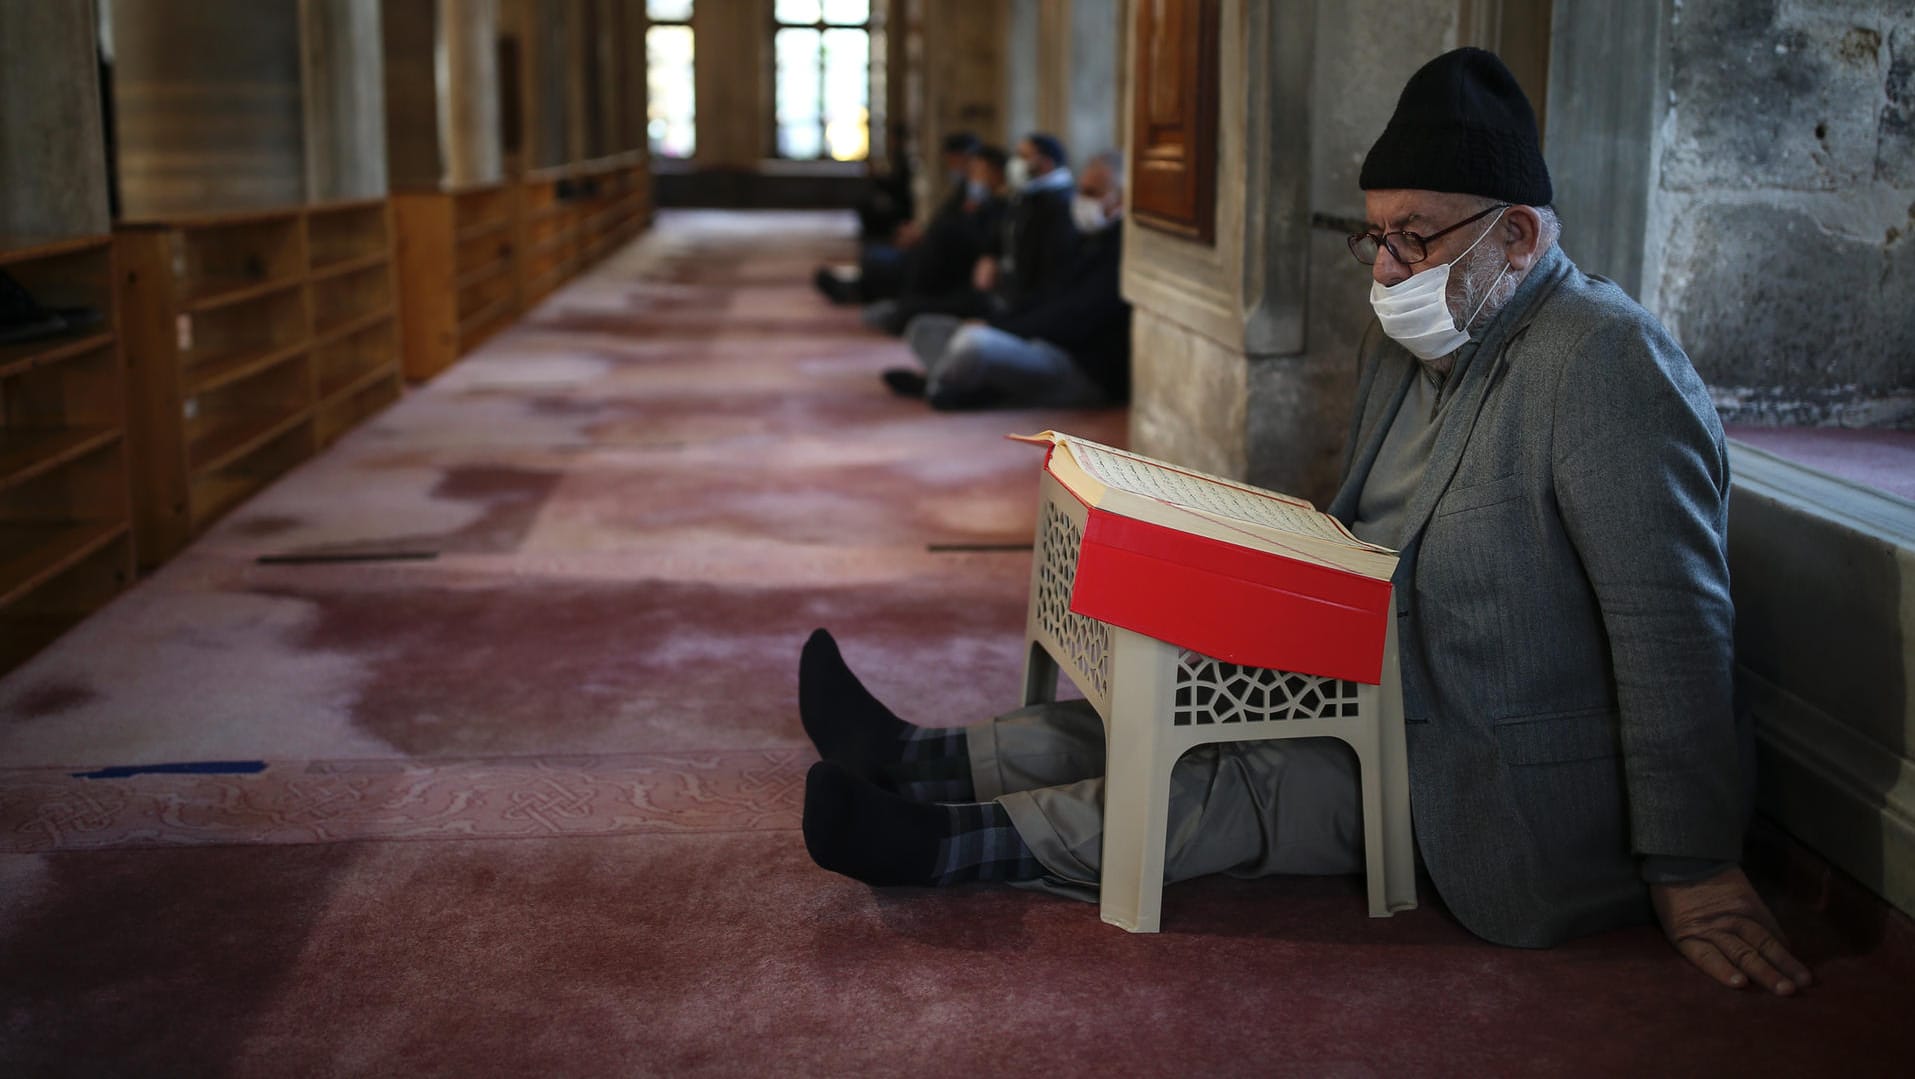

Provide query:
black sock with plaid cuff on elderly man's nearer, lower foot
left=804, top=761, right=1044, bottom=885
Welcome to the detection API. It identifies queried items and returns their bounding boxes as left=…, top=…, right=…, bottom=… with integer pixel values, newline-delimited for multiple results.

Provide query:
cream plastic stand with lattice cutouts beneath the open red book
left=1025, top=471, right=1417, bottom=933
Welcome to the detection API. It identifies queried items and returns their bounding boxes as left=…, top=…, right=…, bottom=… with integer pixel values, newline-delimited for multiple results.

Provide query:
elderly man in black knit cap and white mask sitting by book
left=800, top=50, right=1810, bottom=993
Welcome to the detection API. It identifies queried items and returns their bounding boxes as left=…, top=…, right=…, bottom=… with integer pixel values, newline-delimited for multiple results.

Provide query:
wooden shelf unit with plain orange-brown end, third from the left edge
left=393, top=184, right=519, bottom=379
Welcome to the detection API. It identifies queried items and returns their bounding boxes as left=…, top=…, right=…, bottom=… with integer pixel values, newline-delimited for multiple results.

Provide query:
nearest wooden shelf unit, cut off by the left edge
left=0, top=236, right=134, bottom=671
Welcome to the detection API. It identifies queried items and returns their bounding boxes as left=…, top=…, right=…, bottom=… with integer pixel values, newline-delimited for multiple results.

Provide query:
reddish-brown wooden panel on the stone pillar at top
left=1130, top=0, right=1220, bottom=243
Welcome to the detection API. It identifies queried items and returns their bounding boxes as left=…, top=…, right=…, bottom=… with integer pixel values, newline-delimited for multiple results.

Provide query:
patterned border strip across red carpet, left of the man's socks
left=0, top=749, right=812, bottom=853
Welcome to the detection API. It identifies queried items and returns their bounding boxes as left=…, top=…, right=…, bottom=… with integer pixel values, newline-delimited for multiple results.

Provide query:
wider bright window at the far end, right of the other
left=774, top=0, right=871, bottom=161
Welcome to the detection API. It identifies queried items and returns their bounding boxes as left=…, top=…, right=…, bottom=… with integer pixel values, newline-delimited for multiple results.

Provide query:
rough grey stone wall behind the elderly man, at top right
left=1643, top=0, right=1915, bottom=427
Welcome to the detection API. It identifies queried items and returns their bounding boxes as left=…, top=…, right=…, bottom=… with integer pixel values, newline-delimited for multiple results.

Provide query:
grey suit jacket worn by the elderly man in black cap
left=1331, top=249, right=1746, bottom=947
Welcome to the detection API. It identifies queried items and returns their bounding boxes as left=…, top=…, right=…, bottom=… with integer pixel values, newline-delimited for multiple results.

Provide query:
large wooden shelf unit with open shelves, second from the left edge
left=115, top=199, right=402, bottom=567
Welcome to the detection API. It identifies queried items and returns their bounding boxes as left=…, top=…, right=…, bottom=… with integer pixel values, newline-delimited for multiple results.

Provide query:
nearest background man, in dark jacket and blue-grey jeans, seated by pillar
left=885, top=151, right=1130, bottom=410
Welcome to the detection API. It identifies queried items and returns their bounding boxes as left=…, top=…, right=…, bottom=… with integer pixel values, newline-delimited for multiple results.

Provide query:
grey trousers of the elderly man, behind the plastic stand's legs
left=965, top=701, right=1363, bottom=899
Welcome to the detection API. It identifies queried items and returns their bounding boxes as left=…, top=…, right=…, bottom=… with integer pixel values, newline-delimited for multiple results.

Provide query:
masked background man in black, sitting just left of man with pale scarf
left=864, top=146, right=1009, bottom=333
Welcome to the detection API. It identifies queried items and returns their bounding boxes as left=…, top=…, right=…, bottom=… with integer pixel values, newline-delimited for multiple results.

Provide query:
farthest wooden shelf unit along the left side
left=519, top=153, right=651, bottom=309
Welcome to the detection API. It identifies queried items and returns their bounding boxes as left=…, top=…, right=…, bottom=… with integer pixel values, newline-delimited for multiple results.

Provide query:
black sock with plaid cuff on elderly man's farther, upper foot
left=799, top=629, right=973, bottom=801
